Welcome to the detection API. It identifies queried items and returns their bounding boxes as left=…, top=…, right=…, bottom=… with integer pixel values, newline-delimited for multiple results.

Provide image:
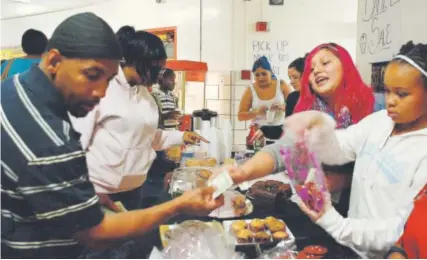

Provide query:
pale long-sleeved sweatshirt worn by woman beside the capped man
left=72, top=69, right=183, bottom=193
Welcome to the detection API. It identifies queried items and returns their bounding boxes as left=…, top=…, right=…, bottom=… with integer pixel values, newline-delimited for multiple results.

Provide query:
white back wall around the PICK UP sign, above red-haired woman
left=233, top=0, right=357, bottom=79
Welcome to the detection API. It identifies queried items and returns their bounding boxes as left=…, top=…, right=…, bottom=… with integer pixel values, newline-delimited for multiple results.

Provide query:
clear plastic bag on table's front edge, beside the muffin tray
left=162, top=221, right=243, bottom=259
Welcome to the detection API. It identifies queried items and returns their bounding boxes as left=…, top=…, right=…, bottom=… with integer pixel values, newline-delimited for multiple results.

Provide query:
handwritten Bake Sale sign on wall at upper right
left=357, top=0, right=402, bottom=62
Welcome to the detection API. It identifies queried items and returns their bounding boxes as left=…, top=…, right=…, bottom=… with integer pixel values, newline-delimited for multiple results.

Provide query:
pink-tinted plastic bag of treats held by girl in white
left=280, top=132, right=327, bottom=212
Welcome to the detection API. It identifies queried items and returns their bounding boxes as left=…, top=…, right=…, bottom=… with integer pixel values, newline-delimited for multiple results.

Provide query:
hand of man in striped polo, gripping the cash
left=177, top=187, right=224, bottom=216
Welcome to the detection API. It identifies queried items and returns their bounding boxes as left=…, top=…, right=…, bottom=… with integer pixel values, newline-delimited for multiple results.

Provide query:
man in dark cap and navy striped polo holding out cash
left=0, top=13, right=223, bottom=258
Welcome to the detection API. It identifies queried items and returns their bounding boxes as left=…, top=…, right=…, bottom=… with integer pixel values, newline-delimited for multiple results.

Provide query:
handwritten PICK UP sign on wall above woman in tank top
left=252, top=40, right=290, bottom=77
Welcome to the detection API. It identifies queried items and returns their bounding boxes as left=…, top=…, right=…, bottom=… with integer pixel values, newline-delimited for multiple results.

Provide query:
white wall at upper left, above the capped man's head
left=1, top=0, right=204, bottom=60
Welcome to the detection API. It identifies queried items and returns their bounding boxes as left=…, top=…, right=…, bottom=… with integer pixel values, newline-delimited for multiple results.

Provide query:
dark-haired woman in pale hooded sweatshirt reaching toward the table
left=73, top=26, right=205, bottom=210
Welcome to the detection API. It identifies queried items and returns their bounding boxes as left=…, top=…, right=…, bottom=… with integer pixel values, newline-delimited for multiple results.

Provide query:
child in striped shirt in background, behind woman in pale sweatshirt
left=152, top=68, right=181, bottom=130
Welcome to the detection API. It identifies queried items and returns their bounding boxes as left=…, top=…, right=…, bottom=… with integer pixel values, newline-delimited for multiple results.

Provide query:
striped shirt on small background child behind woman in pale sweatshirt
left=153, top=89, right=179, bottom=130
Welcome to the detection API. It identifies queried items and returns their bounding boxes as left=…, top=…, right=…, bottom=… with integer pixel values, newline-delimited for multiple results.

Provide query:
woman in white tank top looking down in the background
left=238, top=56, right=293, bottom=142
